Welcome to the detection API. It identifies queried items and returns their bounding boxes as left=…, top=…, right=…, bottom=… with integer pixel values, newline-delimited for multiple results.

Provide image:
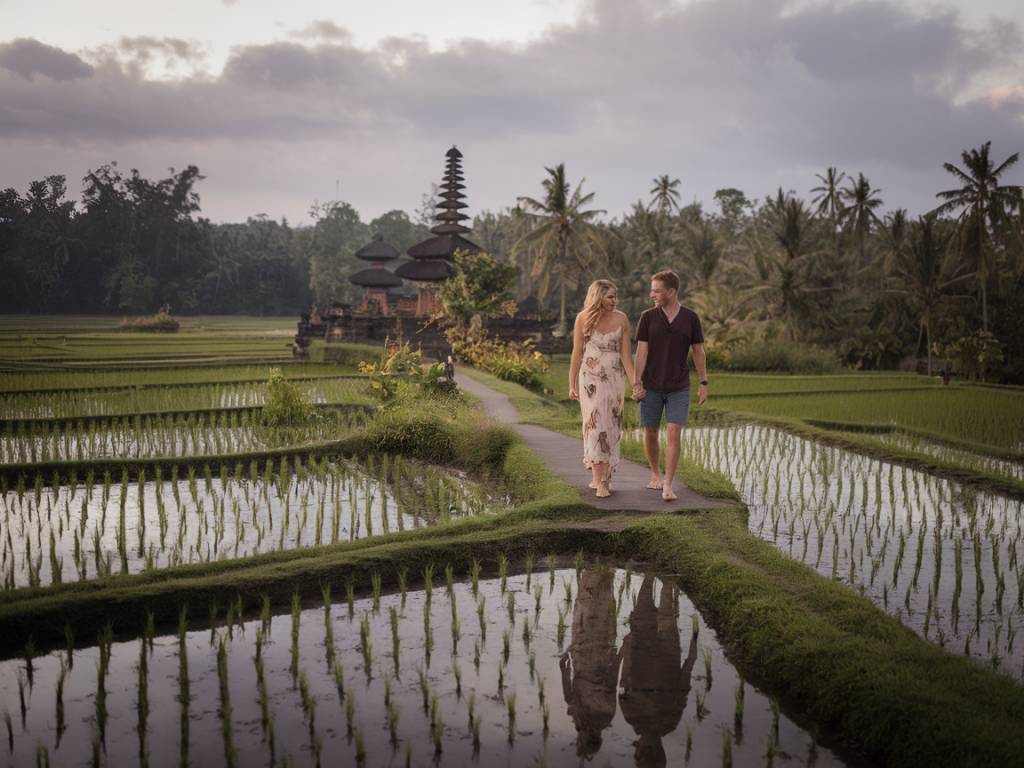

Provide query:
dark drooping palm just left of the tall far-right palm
left=890, top=214, right=972, bottom=376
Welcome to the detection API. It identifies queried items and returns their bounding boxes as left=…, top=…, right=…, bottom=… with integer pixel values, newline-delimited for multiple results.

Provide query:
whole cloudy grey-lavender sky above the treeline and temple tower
left=0, top=0, right=1024, bottom=223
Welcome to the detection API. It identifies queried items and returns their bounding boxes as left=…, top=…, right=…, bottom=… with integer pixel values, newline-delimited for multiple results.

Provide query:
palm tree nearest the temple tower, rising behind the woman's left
left=515, top=163, right=605, bottom=336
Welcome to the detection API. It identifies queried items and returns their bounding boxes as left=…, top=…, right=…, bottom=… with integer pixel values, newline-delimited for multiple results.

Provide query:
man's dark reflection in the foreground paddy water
left=614, top=575, right=697, bottom=766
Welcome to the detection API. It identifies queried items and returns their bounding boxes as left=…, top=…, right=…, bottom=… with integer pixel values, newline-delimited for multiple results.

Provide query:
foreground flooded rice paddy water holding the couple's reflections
left=0, top=567, right=843, bottom=766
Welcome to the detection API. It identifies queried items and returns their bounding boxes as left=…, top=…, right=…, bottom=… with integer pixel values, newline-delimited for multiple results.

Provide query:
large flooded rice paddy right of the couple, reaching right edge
left=632, top=425, right=1024, bottom=680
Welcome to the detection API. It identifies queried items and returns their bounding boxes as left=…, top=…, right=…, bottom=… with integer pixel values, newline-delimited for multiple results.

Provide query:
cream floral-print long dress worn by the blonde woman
left=577, top=326, right=626, bottom=471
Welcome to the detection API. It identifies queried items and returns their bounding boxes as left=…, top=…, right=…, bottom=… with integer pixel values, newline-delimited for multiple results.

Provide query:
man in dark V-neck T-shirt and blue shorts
left=633, top=270, right=708, bottom=502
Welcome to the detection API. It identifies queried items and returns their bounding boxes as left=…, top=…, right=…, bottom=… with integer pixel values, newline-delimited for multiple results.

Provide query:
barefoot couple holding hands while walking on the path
left=569, top=271, right=708, bottom=501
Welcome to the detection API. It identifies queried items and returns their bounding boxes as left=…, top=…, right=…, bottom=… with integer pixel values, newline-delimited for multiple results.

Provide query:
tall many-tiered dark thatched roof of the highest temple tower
left=395, top=146, right=483, bottom=283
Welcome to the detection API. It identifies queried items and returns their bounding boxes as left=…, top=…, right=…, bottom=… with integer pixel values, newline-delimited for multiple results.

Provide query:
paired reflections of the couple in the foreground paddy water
left=561, top=568, right=697, bottom=766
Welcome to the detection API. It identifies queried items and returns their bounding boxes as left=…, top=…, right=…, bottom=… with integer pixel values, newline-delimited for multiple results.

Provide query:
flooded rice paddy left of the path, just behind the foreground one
left=0, top=457, right=504, bottom=589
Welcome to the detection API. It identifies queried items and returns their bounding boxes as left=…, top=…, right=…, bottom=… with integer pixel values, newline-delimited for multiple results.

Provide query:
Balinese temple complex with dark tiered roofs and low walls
left=294, top=146, right=568, bottom=356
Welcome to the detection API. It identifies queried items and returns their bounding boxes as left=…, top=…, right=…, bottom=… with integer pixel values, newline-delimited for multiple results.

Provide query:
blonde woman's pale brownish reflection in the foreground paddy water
left=559, top=568, right=614, bottom=757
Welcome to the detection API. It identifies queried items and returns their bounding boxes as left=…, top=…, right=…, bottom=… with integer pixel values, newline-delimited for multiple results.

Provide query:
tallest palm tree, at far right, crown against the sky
left=935, top=141, right=1021, bottom=331
